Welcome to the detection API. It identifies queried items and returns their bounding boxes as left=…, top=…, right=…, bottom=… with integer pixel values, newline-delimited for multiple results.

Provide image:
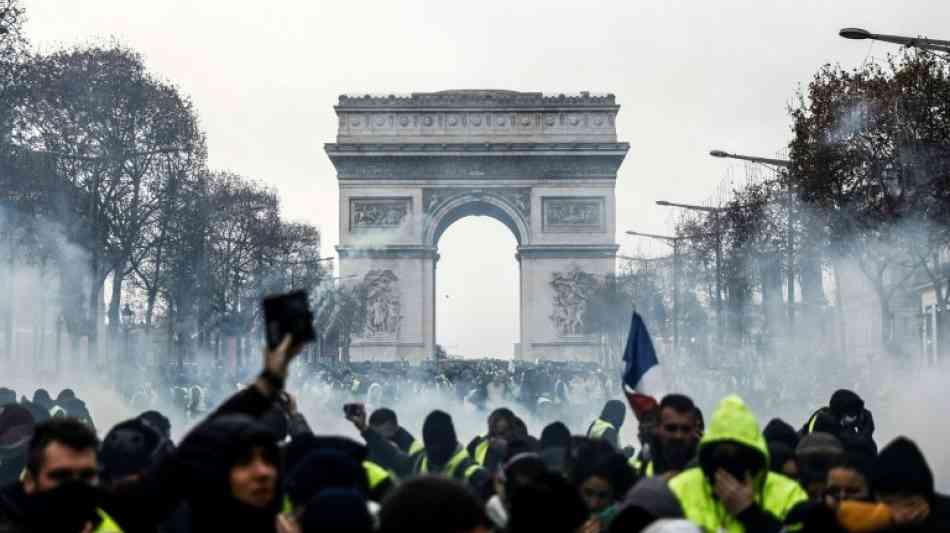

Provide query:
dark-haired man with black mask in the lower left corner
left=0, top=418, right=121, bottom=533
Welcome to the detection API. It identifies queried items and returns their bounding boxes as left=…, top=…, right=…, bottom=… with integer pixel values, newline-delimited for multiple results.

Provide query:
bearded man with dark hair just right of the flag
left=640, top=394, right=699, bottom=479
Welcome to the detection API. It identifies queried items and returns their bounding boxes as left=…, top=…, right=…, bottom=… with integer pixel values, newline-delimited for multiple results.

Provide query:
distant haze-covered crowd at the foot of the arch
left=117, top=359, right=619, bottom=434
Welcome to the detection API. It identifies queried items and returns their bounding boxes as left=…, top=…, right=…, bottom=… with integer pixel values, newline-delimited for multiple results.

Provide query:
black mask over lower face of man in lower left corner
left=24, top=481, right=98, bottom=533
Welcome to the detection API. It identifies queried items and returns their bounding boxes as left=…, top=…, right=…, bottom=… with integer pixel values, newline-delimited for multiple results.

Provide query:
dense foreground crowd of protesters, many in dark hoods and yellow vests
left=0, top=338, right=950, bottom=533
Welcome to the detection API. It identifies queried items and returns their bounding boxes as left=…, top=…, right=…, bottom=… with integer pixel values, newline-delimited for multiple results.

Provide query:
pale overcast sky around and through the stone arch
left=24, top=0, right=950, bottom=355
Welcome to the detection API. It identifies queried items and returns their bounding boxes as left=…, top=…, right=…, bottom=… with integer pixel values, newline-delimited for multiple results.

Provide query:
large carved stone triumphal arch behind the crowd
left=326, top=91, right=629, bottom=360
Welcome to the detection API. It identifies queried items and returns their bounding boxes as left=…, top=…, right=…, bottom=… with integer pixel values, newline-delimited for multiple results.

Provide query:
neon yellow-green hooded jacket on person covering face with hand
left=670, top=395, right=808, bottom=533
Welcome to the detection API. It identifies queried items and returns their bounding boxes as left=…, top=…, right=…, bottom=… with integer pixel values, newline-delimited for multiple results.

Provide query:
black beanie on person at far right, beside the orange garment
left=872, top=437, right=934, bottom=500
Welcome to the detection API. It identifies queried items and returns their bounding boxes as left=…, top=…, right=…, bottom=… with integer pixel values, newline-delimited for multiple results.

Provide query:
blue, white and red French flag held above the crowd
left=623, top=311, right=665, bottom=418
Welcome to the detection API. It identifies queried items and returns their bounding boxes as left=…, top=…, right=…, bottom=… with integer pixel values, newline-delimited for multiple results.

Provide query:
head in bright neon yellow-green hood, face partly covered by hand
left=699, top=394, right=769, bottom=480
